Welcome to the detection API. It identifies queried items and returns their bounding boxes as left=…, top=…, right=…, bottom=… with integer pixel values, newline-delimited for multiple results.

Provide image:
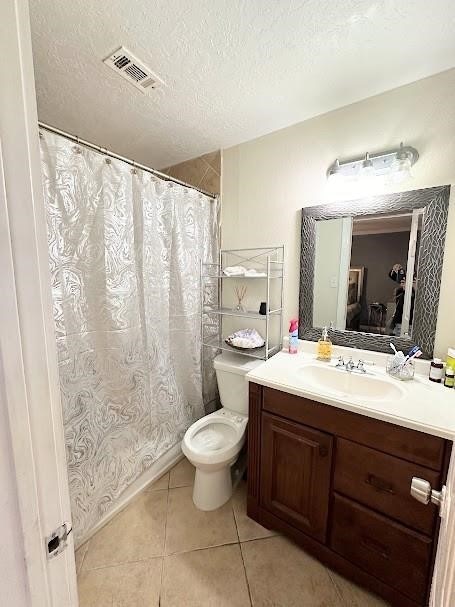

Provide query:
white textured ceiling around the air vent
left=30, top=0, right=455, bottom=167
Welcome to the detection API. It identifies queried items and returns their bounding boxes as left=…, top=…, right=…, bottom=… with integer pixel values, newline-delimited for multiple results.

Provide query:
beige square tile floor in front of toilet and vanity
left=76, top=459, right=386, bottom=607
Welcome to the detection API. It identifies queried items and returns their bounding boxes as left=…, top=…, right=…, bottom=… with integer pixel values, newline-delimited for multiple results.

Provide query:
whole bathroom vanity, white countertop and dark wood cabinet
left=248, top=352, right=455, bottom=607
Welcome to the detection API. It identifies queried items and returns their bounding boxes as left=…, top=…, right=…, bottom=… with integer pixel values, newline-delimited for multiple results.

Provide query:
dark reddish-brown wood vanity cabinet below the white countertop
left=247, top=384, right=452, bottom=607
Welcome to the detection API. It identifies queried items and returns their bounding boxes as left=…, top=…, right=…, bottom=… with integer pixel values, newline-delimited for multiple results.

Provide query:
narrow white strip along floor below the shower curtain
left=75, top=442, right=184, bottom=550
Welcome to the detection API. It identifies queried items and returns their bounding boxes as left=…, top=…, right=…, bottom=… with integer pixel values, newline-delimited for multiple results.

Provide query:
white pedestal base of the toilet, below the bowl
left=193, top=465, right=232, bottom=510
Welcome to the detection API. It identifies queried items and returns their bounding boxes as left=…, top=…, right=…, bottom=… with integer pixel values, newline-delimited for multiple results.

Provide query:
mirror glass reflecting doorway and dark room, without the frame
left=313, top=209, right=423, bottom=337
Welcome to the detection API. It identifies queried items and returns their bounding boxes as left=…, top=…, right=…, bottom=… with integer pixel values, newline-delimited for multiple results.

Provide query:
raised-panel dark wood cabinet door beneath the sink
left=260, top=413, right=332, bottom=541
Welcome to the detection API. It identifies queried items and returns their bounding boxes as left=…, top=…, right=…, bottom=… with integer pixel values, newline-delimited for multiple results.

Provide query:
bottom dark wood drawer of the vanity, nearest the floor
left=330, top=494, right=432, bottom=605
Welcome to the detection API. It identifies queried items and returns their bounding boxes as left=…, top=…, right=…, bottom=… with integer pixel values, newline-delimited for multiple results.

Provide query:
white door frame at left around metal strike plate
left=0, top=0, right=78, bottom=607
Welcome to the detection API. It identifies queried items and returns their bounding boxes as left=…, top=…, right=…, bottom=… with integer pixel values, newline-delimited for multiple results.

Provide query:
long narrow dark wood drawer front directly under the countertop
left=262, top=388, right=445, bottom=472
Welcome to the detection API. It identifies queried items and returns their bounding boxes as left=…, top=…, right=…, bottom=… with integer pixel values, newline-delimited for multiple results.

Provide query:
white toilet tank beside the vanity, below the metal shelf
left=213, top=352, right=263, bottom=415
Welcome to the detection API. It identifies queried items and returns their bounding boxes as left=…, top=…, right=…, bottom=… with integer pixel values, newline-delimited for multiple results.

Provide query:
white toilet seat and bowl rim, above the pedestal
left=182, top=409, right=248, bottom=465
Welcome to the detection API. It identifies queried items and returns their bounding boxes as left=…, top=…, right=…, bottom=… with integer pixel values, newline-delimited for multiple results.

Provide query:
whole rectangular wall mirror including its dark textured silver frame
left=299, top=186, right=450, bottom=358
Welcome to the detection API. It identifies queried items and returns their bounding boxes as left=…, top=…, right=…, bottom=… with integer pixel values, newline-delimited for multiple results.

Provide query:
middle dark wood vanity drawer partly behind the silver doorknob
left=334, top=438, right=440, bottom=535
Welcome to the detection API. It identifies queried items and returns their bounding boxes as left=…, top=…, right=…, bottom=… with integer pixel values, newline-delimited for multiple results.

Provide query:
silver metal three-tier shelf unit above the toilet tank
left=201, top=246, right=284, bottom=360
